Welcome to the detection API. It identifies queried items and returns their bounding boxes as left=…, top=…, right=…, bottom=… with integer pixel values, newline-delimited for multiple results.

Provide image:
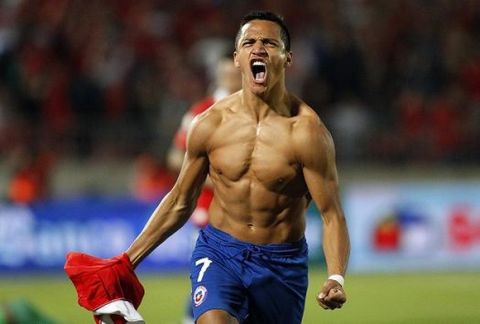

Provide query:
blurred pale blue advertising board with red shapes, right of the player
left=344, top=182, right=480, bottom=272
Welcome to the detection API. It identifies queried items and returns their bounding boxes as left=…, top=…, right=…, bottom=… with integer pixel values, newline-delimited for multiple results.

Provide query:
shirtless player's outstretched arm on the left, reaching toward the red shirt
left=126, top=113, right=219, bottom=268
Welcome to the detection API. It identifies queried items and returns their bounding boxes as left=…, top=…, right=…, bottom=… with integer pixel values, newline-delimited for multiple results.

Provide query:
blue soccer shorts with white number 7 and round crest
left=190, top=225, right=308, bottom=324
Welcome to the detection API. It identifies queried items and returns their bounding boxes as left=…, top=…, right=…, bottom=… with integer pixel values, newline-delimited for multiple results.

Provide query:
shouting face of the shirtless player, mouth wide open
left=234, top=20, right=292, bottom=94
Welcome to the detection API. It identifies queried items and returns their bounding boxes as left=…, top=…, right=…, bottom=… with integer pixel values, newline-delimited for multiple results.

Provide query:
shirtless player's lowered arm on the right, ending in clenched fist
left=295, top=113, right=350, bottom=309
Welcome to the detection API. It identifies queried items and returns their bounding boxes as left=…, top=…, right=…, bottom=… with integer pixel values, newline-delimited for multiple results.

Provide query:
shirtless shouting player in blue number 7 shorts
left=126, top=12, right=350, bottom=324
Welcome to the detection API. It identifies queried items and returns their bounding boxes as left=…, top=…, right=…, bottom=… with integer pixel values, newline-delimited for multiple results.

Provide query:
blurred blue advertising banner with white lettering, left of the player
left=0, top=198, right=320, bottom=273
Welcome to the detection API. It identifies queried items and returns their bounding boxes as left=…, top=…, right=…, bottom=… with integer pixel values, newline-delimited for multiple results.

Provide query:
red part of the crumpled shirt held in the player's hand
left=64, top=252, right=145, bottom=312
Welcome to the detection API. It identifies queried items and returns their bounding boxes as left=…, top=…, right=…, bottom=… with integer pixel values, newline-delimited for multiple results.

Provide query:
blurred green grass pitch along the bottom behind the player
left=0, top=272, right=480, bottom=324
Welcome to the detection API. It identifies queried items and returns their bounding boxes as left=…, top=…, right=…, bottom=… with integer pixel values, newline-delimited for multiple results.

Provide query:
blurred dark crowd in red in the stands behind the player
left=0, top=0, right=480, bottom=202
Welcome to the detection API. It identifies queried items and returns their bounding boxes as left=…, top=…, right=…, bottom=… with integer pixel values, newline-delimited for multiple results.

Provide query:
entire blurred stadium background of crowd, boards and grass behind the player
left=0, top=0, right=480, bottom=323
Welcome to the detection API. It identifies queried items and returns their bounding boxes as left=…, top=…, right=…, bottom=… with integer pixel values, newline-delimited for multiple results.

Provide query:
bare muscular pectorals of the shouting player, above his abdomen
left=209, top=119, right=299, bottom=190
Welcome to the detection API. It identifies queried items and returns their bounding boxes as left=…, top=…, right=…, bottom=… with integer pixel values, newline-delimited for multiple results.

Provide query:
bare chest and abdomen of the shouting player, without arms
left=199, top=93, right=314, bottom=244
